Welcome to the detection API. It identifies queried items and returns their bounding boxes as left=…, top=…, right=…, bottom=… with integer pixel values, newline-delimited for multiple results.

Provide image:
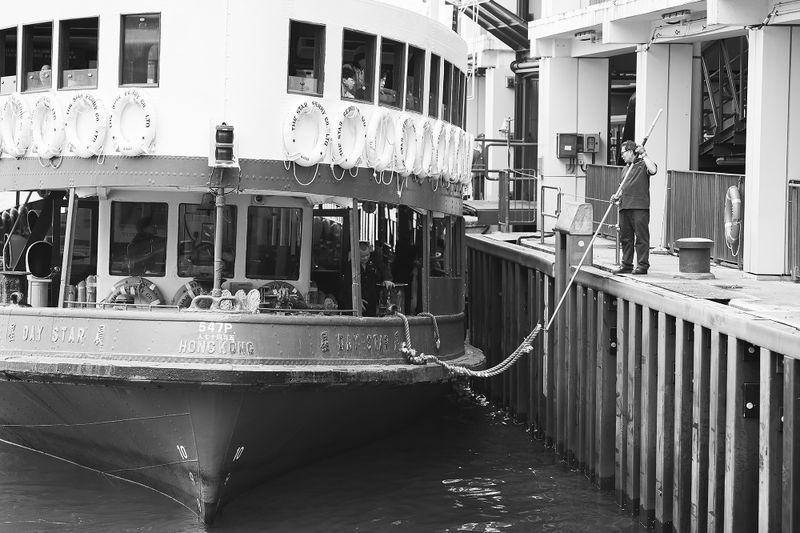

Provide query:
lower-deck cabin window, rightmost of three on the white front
left=245, top=206, right=303, bottom=280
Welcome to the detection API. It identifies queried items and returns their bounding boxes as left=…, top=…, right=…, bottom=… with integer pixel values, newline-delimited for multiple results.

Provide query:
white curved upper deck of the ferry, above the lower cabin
left=0, top=0, right=467, bottom=213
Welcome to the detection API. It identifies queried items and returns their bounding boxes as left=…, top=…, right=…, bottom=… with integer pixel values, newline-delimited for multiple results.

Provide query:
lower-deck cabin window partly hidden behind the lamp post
left=178, top=203, right=241, bottom=279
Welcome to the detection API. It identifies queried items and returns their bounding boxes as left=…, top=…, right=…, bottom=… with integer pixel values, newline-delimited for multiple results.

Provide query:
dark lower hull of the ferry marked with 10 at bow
left=0, top=370, right=447, bottom=523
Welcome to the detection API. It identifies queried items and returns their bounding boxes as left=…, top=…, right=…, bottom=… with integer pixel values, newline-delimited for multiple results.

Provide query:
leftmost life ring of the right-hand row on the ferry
left=283, top=100, right=331, bottom=167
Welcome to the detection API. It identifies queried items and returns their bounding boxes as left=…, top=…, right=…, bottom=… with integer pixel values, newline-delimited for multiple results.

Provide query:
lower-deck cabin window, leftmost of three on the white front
left=108, top=202, right=167, bottom=276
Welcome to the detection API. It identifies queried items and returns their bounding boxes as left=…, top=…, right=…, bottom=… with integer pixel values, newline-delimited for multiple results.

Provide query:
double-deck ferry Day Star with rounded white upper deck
left=0, top=0, right=484, bottom=523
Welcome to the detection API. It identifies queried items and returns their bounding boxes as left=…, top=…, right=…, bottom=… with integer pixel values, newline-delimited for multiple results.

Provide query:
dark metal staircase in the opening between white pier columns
left=700, top=37, right=747, bottom=172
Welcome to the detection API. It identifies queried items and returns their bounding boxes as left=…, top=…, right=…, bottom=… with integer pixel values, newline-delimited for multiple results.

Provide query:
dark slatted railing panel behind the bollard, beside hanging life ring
left=666, top=170, right=744, bottom=268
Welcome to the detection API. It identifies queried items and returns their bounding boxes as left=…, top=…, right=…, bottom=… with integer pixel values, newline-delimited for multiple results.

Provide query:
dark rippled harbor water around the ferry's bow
left=0, top=389, right=644, bottom=533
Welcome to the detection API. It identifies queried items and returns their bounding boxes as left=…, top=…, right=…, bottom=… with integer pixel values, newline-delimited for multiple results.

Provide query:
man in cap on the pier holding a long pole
left=611, top=141, right=658, bottom=275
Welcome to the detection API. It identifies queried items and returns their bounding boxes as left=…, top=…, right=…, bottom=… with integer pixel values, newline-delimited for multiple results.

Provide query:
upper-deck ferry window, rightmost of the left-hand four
left=119, top=13, right=161, bottom=85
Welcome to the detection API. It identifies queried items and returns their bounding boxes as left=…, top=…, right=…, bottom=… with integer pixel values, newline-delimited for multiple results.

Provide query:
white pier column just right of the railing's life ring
left=743, top=26, right=800, bottom=275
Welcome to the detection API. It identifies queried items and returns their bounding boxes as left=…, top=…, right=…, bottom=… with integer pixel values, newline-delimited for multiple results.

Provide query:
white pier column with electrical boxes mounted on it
left=537, top=57, right=608, bottom=229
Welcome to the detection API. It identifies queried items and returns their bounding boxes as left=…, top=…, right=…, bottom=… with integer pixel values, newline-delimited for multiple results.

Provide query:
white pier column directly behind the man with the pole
left=636, top=44, right=692, bottom=246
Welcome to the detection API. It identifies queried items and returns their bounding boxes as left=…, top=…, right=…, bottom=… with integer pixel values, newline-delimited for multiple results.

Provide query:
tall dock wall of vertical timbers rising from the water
left=467, top=235, right=800, bottom=531
